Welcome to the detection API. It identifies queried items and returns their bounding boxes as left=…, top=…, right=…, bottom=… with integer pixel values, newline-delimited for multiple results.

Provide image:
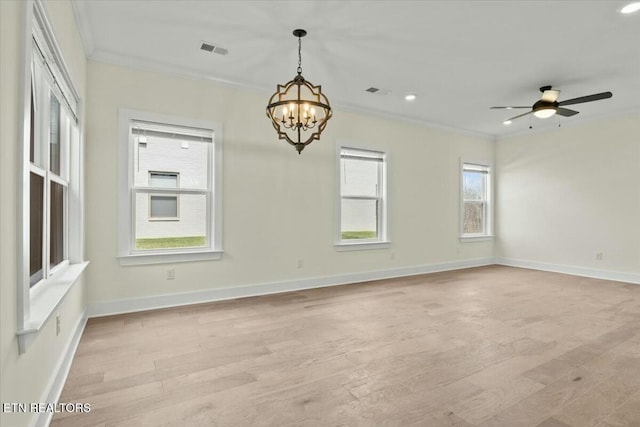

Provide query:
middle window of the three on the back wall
left=336, top=147, right=387, bottom=245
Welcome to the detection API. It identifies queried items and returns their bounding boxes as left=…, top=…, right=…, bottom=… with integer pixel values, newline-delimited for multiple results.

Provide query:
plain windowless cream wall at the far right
left=496, top=113, right=640, bottom=277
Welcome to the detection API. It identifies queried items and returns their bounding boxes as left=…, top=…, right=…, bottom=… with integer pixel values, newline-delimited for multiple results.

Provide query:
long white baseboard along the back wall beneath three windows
left=87, top=257, right=494, bottom=317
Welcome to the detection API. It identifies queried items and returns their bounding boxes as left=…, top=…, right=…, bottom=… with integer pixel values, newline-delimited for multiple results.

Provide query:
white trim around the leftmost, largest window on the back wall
left=117, top=108, right=223, bottom=266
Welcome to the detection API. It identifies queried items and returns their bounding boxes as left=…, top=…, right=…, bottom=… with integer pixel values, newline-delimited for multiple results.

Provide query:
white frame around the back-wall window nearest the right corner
left=460, top=159, right=493, bottom=242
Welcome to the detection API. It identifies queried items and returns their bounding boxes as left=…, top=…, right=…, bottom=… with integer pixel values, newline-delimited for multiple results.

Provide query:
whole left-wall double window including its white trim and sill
left=17, top=1, right=87, bottom=353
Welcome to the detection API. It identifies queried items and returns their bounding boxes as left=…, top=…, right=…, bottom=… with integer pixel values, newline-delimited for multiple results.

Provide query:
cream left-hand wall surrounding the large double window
left=0, top=1, right=86, bottom=427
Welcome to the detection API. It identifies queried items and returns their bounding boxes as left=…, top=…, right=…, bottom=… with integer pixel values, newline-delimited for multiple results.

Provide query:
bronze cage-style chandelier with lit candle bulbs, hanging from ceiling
left=267, top=29, right=332, bottom=154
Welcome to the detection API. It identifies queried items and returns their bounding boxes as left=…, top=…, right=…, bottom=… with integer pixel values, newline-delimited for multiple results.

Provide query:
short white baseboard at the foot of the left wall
left=32, top=310, right=87, bottom=427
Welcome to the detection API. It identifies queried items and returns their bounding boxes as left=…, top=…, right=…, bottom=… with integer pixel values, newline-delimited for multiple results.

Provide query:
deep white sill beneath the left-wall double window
left=17, top=261, right=89, bottom=354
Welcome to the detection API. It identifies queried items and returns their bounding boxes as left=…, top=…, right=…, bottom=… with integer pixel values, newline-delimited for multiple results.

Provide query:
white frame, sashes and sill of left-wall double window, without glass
left=17, top=0, right=88, bottom=353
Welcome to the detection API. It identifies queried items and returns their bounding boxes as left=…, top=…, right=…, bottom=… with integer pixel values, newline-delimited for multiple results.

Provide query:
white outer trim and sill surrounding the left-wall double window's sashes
left=16, top=0, right=88, bottom=354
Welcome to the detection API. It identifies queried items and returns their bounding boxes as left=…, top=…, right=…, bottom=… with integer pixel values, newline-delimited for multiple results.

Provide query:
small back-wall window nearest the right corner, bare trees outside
left=460, top=162, right=492, bottom=238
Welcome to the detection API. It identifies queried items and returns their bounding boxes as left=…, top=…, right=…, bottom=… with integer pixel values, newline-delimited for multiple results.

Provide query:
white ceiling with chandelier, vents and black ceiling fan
left=73, top=0, right=640, bottom=136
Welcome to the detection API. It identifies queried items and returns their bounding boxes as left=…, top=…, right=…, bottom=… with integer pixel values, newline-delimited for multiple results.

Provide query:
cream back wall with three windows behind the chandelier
left=86, top=61, right=493, bottom=304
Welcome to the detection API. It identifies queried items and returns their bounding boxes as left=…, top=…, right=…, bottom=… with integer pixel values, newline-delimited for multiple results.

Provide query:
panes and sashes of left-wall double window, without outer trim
left=25, top=18, right=79, bottom=287
